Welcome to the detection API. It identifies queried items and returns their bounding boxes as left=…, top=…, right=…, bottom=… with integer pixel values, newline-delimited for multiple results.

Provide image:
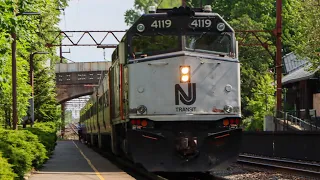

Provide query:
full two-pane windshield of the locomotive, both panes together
left=130, top=32, right=234, bottom=59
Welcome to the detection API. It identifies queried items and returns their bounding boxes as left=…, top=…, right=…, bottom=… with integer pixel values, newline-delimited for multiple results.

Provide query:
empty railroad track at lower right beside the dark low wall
left=237, top=154, right=320, bottom=177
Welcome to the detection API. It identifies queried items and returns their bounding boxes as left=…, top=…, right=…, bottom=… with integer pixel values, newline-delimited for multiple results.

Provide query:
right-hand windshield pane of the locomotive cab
left=185, top=32, right=234, bottom=57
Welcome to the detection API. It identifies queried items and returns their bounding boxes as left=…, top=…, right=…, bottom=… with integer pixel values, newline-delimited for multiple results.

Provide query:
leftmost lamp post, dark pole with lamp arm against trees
left=11, top=12, right=40, bottom=130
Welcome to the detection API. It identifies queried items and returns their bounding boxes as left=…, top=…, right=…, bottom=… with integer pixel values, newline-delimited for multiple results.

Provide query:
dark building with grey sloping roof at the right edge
left=282, top=53, right=320, bottom=119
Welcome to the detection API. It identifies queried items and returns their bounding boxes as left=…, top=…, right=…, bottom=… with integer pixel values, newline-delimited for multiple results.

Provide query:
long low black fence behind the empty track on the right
left=241, top=131, right=320, bottom=162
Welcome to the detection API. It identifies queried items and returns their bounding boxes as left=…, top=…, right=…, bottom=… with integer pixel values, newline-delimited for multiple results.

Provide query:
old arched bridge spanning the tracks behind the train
left=55, top=62, right=111, bottom=103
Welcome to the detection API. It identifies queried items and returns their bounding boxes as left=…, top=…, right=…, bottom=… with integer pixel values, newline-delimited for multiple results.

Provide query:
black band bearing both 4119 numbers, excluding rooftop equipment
left=131, top=16, right=231, bottom=33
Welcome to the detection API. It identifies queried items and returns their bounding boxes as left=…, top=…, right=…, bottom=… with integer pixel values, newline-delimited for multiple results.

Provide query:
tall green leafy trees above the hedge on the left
left=0, top=0, right=67, bottom=126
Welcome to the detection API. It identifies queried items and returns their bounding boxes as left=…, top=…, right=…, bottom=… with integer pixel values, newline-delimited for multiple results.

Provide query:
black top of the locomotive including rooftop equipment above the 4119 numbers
left=127, top=7, right=234, bottom=35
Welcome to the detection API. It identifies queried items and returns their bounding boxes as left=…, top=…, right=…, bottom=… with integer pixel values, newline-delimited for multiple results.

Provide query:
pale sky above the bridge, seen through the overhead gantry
left=58, top=0, right=134, bottom=62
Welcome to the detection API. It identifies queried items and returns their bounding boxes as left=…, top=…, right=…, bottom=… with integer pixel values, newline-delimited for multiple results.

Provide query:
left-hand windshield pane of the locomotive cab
left=130, top=34, right=181, bottom=59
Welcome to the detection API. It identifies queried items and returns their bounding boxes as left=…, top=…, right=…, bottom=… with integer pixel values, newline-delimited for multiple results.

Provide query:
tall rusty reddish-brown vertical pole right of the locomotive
left=275, top=0, right=282, bottom=113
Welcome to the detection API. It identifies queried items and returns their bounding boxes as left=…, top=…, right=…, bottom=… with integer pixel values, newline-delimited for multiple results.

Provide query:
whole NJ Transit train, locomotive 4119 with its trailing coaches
left=80, top=7, right=242, bottom=172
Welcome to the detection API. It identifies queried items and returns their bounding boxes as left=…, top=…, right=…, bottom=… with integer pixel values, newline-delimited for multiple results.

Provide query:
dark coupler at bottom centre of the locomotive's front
left=175, top=133, right=199, bottom=160
